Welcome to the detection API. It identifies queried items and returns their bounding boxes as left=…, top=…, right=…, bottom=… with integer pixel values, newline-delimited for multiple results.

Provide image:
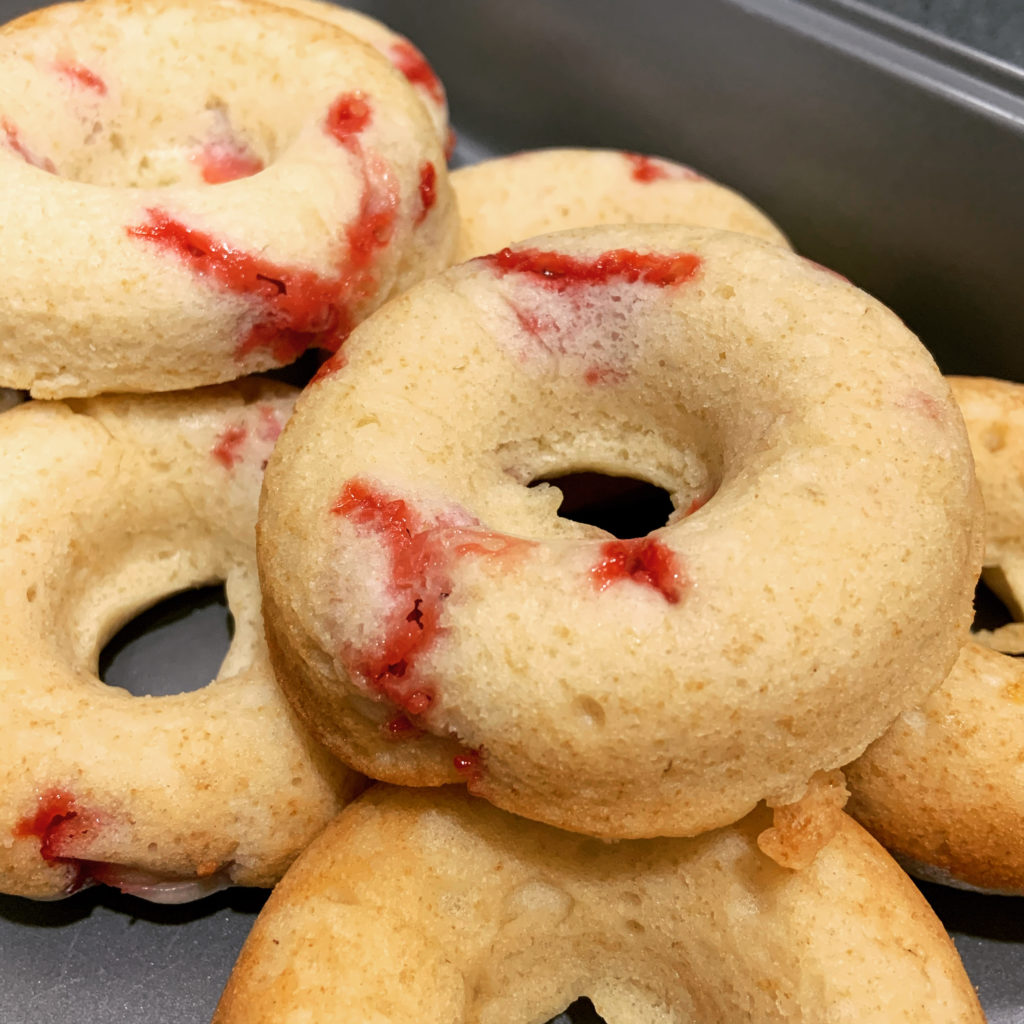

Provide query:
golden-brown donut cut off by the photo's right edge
left=847, top=378, right=1024, bottom=895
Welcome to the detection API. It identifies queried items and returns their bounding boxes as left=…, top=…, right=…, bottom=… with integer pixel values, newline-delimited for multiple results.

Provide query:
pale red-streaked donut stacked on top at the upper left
left=0, top=0, right=458, bottom=398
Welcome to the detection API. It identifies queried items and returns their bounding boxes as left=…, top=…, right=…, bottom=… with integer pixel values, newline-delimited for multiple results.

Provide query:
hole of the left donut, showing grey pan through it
left=98, top=584, right=234, bottom=696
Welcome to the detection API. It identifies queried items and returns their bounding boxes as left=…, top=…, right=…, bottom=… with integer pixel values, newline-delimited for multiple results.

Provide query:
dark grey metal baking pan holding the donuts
left=0, top=0, right=1024, bottom=1024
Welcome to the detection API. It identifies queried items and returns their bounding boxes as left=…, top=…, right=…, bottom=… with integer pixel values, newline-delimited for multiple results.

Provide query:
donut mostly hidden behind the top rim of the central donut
left=452, top=150, right=788, bottom=262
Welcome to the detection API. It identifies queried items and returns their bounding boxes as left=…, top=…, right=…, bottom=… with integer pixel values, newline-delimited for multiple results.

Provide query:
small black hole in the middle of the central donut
left=529, top=472, right=675, bottom=540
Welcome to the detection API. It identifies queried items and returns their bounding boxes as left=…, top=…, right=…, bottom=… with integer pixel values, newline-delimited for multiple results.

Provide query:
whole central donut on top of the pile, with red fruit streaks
left=257, top=225, right=982, bottom=838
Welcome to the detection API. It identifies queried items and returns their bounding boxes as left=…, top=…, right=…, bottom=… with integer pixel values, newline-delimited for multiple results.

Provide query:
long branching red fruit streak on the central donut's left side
left=332, top=479, right=526, bottom=712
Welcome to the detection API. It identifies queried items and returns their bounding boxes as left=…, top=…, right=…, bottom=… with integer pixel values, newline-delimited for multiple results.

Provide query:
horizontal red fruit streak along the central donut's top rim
left=480, top=249, right=700, bottom=292
